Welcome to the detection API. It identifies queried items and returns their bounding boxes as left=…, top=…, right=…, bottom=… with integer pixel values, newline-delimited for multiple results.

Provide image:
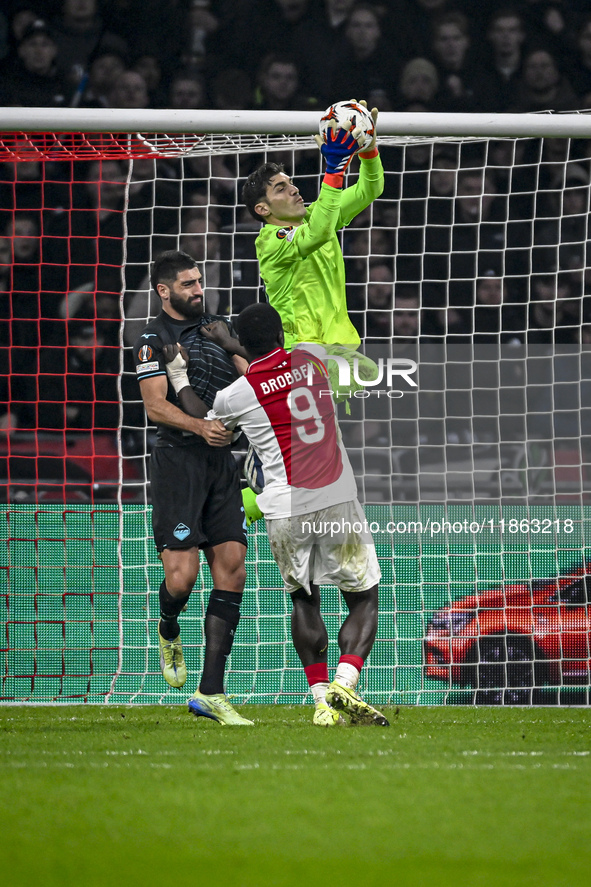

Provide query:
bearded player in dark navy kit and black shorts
left=134, top=250, right=252, bottom=726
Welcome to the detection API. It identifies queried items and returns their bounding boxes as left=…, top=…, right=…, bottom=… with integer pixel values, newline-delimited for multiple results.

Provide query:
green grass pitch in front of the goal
left=0, top=705, right=591, bottom=887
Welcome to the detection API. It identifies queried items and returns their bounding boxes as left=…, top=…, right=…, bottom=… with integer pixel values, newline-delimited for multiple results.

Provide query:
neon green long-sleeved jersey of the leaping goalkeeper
left=256, top=155, right=384, bottom=349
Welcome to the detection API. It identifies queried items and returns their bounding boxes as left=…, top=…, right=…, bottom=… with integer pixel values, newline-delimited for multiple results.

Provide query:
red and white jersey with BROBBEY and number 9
left=208, top=348, right=357, bottom=518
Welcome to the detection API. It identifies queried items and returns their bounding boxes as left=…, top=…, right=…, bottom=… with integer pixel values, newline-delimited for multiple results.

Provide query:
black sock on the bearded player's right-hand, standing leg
left=199, top=588, right=242, bottom=696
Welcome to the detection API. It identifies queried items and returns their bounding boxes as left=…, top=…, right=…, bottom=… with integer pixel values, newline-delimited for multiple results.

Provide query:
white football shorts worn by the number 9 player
left=266, top=499, right=381, bottom=594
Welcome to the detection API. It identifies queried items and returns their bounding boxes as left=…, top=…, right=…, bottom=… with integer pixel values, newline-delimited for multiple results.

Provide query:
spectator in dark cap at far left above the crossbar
left=0, top=19, right=72, bottom=108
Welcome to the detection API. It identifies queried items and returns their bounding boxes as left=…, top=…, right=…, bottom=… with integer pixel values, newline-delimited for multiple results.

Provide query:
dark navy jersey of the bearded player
left=133, top=311, right=239, bottom=446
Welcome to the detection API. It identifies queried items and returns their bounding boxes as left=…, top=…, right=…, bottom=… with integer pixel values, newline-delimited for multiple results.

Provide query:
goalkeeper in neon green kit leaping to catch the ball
left=242, top=103, right=384, bottom=400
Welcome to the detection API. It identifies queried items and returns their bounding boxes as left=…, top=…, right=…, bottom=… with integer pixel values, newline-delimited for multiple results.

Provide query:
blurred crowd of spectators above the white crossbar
left=0, top=0, right=591, bottom=112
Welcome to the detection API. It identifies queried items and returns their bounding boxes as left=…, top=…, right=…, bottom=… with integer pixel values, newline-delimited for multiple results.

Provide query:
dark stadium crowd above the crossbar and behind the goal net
left=0, top=0, right=591, bottom=500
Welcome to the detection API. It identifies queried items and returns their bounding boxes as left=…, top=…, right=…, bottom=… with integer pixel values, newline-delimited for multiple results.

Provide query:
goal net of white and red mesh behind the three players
left=0, top=109, right=591, bottom=704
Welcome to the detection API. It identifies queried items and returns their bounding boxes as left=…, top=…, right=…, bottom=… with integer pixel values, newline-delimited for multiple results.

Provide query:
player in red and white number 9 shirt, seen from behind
left=208, top=303, right=388, bottom=726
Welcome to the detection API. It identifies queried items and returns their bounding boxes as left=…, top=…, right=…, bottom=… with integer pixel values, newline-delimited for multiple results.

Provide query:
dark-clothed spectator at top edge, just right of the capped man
left=52, top=0, right=128, bottom=91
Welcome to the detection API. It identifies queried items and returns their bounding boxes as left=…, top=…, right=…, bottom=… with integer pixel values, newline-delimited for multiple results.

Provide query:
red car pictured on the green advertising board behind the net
left=424, top=561, right=591, bottom=705
